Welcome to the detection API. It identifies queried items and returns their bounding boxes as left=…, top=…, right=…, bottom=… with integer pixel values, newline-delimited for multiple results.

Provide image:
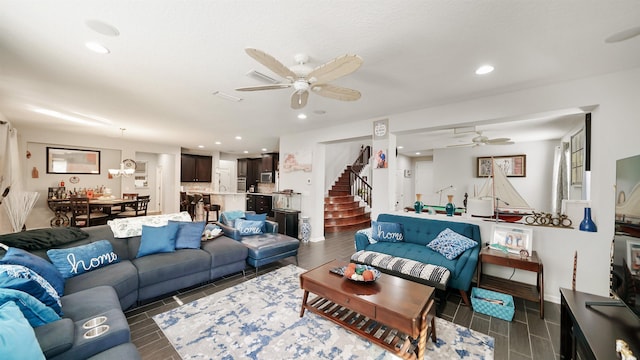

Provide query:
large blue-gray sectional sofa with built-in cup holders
left=0, top=215, right=248, bottom=359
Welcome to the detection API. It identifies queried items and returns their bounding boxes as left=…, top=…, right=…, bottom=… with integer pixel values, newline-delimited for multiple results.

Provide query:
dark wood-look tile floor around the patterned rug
left=126, top=231, right=560, bottom=360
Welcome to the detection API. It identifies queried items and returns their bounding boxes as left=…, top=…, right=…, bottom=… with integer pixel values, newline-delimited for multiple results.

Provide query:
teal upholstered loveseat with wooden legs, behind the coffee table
left=352, top=214, right=482, bottom=305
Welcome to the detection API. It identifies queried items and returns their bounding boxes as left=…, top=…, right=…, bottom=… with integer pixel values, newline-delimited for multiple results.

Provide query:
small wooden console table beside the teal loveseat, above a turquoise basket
left=478, top=248, right=544, bottom=319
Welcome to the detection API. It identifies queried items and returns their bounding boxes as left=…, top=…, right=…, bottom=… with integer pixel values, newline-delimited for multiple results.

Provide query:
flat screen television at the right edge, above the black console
left=611, top=155, right=640, bottom=317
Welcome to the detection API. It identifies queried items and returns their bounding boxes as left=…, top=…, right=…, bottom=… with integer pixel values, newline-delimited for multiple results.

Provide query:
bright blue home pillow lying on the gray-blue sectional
left=47, top=240, right=120, bottom=279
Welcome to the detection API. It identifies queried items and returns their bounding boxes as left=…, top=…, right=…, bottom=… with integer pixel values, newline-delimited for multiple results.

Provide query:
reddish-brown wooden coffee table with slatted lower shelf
left=300, top=260, right=436, bottom=359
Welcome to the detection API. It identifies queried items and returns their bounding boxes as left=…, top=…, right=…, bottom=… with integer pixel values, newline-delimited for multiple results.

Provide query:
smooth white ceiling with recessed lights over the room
left=0, top=0, right=640, bottom=154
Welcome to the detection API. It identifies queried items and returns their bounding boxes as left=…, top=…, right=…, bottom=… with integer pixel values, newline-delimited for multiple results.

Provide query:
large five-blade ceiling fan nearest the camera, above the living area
left=236, top=48, right=362, bottom=109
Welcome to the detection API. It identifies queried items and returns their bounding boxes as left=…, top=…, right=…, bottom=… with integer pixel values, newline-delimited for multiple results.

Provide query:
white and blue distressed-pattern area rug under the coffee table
left=153, top=265, right=494, bottom=360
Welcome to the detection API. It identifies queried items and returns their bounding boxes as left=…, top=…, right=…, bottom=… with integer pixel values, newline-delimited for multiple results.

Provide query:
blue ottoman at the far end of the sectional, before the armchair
left=240, top=233, right=300, bottom=272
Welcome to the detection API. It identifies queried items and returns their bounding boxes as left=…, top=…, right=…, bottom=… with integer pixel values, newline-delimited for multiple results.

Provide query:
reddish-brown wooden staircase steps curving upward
left=324, top=166, right=371, bottom=233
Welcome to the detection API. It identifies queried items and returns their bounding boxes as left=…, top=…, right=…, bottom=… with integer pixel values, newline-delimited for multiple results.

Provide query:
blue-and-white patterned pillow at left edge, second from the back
left=0, top=265, right=62, bottom=315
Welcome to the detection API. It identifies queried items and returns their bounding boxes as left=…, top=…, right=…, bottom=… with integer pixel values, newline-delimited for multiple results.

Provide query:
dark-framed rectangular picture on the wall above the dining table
left=47, top=146, right=100, bottom=175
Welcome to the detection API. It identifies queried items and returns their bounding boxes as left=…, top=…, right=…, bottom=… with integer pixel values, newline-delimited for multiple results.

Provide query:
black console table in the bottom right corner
left=560, top=288, right=640, bottom=359
